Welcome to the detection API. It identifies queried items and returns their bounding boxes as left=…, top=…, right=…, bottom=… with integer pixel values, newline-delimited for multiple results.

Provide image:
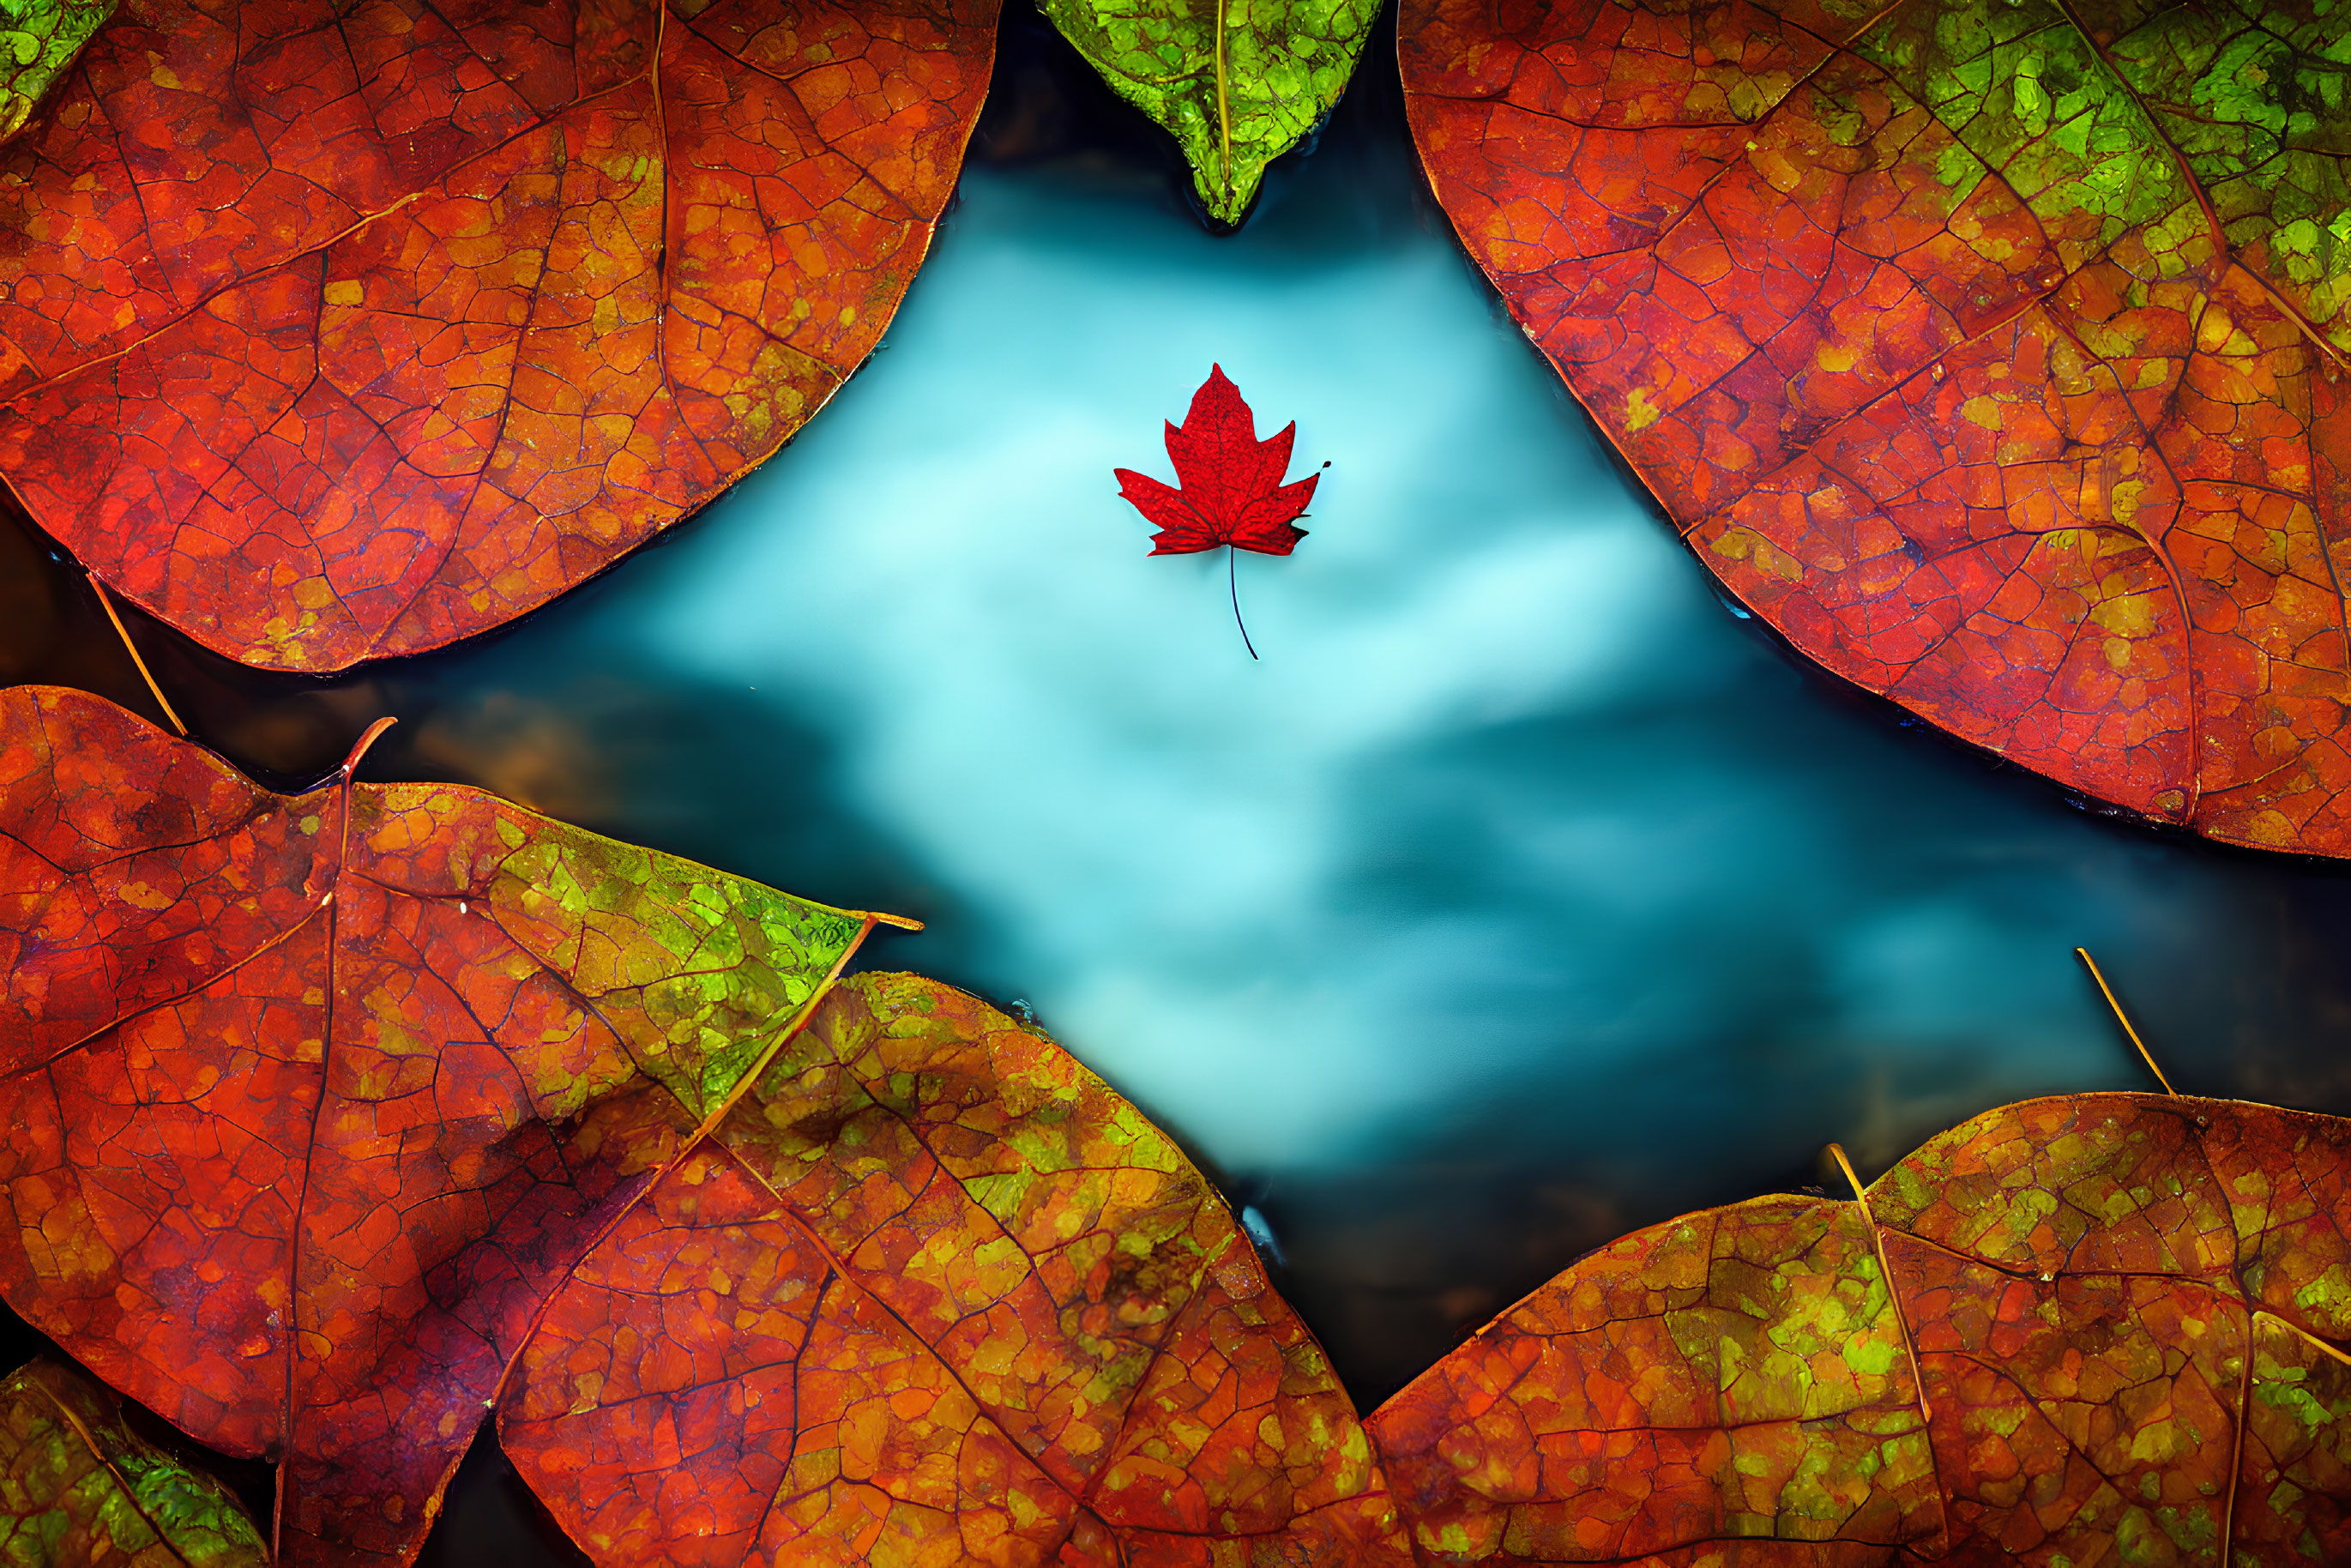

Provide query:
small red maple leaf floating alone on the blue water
left=1112, top=365, right=1329, bottom=658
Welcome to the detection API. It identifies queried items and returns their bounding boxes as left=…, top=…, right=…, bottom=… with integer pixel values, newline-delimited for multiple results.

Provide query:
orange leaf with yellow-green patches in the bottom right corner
left=1366, top=1093, right=2351, bottom=1568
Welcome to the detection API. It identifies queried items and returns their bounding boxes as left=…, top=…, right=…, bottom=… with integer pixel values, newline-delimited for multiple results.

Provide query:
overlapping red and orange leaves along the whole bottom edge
left=14, top=686, right=2351, bottom=1568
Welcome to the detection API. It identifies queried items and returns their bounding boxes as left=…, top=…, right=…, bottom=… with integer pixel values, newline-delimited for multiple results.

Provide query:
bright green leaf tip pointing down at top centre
left=1040, top=0, right=1380, bottom=223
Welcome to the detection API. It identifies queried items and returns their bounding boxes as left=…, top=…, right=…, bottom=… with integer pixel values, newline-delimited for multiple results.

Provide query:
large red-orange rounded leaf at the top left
left=0, top=0, right=994, bottom=670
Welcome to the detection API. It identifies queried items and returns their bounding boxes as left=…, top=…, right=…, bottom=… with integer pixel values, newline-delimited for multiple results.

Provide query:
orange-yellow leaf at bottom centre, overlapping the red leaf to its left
left=498, top=975, right=1411, bottom=1568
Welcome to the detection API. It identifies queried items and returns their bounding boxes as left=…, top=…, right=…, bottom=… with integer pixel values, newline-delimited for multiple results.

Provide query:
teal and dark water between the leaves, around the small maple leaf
left=0, top=14, right=2351, bottom=1564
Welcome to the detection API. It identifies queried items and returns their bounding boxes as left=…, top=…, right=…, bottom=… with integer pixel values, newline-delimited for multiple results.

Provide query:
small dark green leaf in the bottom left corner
left=0, top=1361, right=270, bottom=1568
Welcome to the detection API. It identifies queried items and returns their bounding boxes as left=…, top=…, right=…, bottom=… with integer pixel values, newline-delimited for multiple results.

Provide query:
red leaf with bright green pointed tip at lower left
left=0, top=686, right=898, bottom=1564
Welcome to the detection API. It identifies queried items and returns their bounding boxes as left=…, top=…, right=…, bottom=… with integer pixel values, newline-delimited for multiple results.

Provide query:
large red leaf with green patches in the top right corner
left=1399, top=0, right=2351, bottom=856
